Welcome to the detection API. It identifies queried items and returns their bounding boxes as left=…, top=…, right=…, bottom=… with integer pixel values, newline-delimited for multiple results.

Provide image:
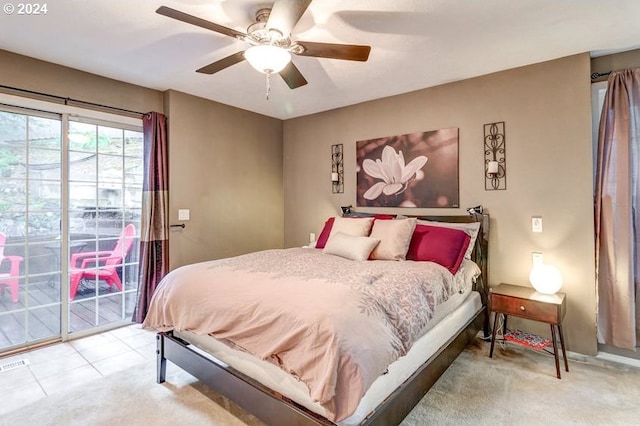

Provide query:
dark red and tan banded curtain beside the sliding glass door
left=133, top=112, right=169, bottom=323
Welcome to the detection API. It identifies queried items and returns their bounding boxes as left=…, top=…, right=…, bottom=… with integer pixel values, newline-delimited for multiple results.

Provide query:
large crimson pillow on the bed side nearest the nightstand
left=407, top=225, right=471, bottom=275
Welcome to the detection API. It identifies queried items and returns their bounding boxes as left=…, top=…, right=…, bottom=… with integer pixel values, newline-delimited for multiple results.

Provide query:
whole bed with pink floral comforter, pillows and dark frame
left=144, top=214, right=489, bottom=426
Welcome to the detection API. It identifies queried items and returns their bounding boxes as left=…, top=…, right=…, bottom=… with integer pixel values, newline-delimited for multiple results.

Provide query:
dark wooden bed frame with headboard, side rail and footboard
left=157, top=214, right=490, bottom=426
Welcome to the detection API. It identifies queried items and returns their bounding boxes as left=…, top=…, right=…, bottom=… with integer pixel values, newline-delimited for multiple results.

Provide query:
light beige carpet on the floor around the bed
left=0, top=340, right=640, bottom=426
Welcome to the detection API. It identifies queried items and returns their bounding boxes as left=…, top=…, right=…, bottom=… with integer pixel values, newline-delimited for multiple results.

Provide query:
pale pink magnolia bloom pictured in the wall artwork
left=362, top=145, right=427, bottom=200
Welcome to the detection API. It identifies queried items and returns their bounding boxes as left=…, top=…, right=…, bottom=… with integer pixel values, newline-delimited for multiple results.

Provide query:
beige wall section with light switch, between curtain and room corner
left=165, top=91, right=284, bottom=269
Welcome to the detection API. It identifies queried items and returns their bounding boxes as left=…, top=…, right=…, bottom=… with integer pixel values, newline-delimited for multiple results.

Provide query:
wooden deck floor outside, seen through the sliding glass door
left=0, top=278, right=136, bottom=353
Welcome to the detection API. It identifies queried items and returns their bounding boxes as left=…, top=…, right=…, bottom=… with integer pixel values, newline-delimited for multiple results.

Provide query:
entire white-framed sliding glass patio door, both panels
left=0, top=106, right=143, bottom=353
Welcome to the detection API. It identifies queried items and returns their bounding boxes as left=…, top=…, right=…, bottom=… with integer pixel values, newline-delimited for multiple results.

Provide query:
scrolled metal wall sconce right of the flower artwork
left=484, top=121, right=507, bottom=190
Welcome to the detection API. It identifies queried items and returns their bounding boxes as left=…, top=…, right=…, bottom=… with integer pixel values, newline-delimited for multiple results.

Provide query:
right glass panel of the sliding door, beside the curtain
left=68, top=121, right=143, bottom=332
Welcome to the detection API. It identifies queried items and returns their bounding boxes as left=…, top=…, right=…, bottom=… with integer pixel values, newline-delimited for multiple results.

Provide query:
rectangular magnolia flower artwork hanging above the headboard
left=356, top=128, right=459, bottom=208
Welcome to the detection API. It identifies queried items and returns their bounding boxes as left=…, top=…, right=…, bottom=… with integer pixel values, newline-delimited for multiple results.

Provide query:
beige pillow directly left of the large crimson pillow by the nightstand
left=370, top=219, right=416, bottom=260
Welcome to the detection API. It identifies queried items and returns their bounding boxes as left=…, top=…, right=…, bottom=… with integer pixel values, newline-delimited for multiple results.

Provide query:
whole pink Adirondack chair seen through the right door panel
left=69, top=224, right=136, bottom=299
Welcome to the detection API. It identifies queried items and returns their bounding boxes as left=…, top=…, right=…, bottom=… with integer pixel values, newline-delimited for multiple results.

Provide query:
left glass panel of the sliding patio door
left=0, top=109, right=62, bottom=350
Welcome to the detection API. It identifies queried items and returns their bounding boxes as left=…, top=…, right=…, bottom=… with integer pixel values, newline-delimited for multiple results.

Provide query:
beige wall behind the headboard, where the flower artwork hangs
left=284, top=54, right=596, bottom=354
